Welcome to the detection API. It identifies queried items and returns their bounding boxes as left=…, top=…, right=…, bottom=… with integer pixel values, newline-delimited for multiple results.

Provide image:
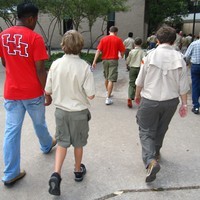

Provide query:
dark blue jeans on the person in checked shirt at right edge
left=191, top=64, right=200, bottom=108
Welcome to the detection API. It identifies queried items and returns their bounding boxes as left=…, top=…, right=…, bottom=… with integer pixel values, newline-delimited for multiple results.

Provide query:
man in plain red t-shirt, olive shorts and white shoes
left=92, top=26, right=125, bottom=105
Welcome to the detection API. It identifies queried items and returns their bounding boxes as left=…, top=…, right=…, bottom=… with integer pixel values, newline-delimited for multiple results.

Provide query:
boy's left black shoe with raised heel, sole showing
left=49, top=172, right=62, bottom=196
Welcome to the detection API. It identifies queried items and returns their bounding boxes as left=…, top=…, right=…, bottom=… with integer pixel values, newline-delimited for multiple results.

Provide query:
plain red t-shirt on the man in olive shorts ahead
left=97, top=35, right=125, bottom=60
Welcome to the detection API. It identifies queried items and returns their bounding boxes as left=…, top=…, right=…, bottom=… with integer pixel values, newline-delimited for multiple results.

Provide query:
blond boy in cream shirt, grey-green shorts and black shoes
left=45, top=30, right=95, bottom=196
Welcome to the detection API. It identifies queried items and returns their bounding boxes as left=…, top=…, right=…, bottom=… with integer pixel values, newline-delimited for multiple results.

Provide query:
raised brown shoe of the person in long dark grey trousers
left=146, top=160, right=160, bottom=183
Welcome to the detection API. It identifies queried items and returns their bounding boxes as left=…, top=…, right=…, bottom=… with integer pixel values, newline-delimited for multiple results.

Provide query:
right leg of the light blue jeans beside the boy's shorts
left=23, top=96, right=53, bottom=153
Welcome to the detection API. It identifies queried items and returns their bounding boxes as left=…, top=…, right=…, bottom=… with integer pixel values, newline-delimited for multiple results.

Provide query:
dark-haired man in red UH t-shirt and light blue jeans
left=0, top=3, right=56, bottom=185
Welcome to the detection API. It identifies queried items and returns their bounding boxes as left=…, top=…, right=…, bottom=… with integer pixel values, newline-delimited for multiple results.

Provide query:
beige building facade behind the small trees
left=0, top=0, right=147, bottom=49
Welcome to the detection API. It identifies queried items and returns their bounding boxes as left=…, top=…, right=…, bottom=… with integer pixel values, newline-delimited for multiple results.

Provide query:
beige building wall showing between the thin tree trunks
left=0, top=0, right=147, bottom=48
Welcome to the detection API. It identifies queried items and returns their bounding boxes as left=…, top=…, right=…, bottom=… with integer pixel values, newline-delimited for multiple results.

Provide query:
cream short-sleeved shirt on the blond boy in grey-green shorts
left=45, top=54, right=95, bottom=111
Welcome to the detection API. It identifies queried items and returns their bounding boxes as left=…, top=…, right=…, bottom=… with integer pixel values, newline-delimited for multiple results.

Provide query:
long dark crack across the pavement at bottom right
left=94, top=185, right=200, bottom=200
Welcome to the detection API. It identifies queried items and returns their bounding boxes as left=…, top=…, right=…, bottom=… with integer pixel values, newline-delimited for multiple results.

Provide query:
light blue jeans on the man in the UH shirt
left=2, top=96, right=52, bottom=181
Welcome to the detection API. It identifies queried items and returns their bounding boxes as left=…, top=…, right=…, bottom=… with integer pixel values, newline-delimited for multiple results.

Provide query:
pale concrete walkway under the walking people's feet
left=0, top=60, right=200, bottom=200
